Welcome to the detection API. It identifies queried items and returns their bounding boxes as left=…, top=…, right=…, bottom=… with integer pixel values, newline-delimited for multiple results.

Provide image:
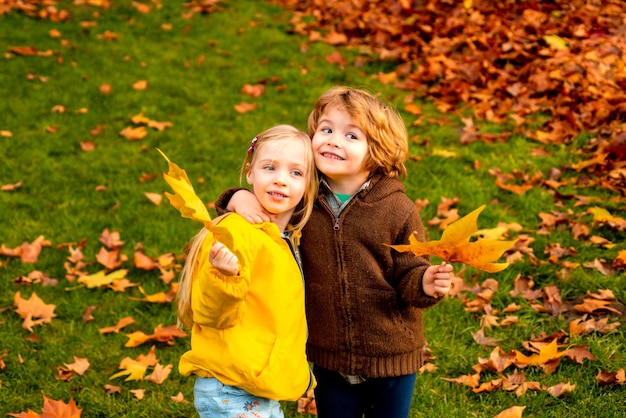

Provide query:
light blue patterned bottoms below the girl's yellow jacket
left=193, top=377, right=284, bottom=418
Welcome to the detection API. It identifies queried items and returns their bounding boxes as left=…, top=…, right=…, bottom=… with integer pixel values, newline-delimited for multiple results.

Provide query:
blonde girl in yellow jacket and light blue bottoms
left=177, top=125, right=317, bottom=418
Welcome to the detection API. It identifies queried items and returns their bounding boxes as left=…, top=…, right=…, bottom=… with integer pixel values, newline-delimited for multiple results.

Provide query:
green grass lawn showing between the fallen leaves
left=0, top=0, right=626, bottom=417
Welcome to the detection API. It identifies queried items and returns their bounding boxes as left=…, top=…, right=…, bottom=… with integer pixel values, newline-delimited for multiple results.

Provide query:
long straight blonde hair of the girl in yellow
left=176, top=125, right=318, bottom=328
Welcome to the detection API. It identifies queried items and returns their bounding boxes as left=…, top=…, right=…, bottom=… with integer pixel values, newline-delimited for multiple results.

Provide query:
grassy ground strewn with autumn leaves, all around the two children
left=0, top=0, right=626, bottom=417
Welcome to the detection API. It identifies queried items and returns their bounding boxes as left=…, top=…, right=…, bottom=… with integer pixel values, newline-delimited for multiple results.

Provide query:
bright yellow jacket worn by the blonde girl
left=179, top=214, right=315, bottom=401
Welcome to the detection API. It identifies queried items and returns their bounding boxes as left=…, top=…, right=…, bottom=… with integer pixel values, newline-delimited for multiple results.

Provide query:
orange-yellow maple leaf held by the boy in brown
left=390, top=205, right=517, bottom=273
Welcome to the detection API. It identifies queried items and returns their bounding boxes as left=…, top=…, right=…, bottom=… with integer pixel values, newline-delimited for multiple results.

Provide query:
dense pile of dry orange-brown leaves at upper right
left=272, top=0, right=626, bottom=196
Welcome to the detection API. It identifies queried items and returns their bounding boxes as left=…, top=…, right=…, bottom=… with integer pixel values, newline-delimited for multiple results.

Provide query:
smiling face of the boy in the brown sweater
left=311, top=107, right=370, bottom=194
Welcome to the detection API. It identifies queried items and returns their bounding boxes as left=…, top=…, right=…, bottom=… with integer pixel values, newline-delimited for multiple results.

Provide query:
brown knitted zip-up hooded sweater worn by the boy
left=216, top=175, right=438, bottom=377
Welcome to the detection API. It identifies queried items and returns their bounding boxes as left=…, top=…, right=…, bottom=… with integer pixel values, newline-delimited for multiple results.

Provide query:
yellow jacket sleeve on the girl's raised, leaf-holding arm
left=191, top=237, right=250, bottom=329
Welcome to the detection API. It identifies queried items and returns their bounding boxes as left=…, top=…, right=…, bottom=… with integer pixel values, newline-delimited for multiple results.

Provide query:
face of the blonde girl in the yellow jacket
left=246, top=140, right=310, bottom=223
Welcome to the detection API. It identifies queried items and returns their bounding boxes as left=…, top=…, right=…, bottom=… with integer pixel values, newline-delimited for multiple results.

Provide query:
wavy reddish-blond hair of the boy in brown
left=308, top=86, right=409, bottom=178
